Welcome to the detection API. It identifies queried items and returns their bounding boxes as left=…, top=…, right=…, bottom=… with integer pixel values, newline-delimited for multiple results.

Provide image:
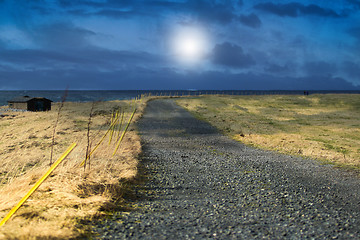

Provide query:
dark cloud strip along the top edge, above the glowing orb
left=60, top=0, right=236, bottom=24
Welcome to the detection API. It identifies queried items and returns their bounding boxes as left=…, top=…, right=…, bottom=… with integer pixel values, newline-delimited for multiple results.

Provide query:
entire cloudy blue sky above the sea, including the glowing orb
left=0, top=0, right=360, bottom=90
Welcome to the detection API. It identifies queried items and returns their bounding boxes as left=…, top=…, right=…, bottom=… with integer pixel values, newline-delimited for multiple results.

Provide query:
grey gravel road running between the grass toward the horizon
left=94, top=99, right=360, bottom=239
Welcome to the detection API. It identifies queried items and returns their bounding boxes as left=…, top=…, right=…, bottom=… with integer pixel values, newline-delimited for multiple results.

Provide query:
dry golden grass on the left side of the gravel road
left=0, top=100, right=146, bottom=239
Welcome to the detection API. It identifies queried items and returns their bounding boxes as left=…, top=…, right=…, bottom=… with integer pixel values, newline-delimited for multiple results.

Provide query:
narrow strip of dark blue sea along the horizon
left=0, top=89, right=360, bottom=106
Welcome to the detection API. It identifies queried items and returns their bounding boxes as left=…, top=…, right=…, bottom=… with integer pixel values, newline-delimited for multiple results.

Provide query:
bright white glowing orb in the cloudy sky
left=171, top=26, right=208, bottom=63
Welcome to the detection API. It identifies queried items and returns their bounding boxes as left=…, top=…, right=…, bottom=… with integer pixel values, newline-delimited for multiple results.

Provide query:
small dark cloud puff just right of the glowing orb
left=211, top=42, right=255, bottom=68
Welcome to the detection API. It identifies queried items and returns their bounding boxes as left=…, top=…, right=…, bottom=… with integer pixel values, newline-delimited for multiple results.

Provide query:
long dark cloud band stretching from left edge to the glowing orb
left=1, top=48, right=166, bottom=71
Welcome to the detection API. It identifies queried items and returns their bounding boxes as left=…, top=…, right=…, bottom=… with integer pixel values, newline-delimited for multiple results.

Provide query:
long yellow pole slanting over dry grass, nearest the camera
left=0, top=143, right=76, bottom=227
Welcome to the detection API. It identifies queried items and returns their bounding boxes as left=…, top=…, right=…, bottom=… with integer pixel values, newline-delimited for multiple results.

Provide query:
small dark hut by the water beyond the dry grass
left=8, top=96, right=52, bottom=112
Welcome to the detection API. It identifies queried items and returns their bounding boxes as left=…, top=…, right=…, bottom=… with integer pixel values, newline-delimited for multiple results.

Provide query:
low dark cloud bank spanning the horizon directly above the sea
left=0, top=68, right=359, bottom=90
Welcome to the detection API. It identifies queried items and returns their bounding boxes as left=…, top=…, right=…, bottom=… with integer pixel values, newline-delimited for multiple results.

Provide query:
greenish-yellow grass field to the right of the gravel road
left=177, top=94, right=360, bottom=170
